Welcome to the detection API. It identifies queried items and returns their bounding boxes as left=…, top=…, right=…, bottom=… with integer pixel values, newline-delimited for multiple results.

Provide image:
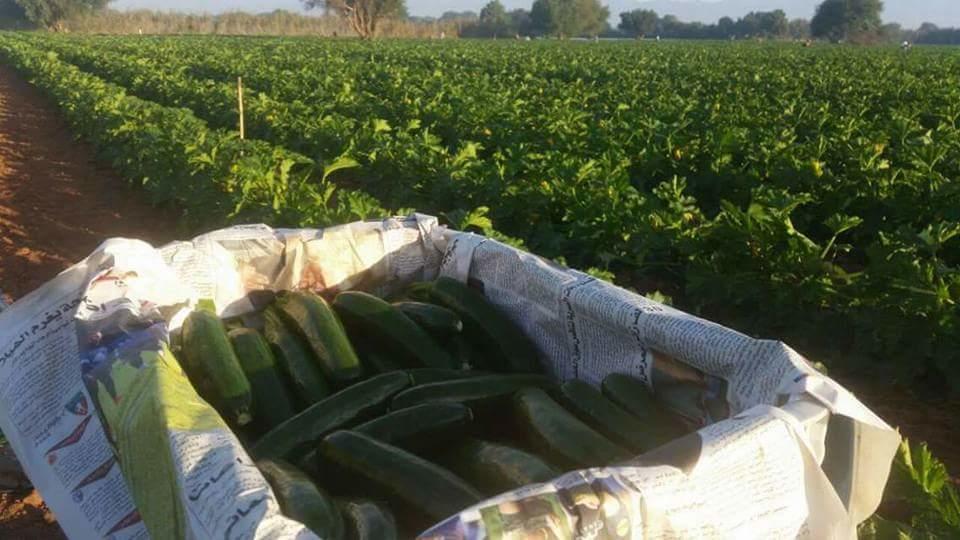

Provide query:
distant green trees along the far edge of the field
left=0, top=0, right=960, bottom=44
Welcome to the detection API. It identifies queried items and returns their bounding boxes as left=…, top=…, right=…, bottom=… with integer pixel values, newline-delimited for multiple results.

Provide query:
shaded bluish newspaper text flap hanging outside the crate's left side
left=0, top=291, right=147, bottom=540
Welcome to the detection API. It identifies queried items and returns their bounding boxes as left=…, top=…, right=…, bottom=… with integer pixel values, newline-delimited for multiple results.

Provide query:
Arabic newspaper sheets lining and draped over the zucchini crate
left=0, top=215, right=899, bottom=540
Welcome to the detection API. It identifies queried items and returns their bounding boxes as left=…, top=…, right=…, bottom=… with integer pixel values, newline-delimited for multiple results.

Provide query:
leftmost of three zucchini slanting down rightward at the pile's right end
left=513, top=388, right=630, bottom=469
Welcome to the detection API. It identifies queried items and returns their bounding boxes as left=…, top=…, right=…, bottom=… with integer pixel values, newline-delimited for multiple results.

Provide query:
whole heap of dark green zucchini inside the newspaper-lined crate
left=174, top=278, right=690, bottom=539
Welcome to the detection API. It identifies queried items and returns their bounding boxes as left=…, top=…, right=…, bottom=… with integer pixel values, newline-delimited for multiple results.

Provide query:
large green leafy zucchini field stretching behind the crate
left=0, top=33, right=960, bottom=393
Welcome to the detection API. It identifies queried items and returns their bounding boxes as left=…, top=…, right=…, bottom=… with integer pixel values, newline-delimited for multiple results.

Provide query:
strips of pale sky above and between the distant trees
left=111, top=0, right=960, bottom=27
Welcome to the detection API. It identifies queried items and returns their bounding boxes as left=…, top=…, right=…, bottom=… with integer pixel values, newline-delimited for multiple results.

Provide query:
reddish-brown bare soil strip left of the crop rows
left=0, top=65, right=181, bottom=540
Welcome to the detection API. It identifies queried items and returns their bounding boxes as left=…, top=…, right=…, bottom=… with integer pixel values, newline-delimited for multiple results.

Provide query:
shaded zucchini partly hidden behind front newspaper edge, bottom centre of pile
left=435, top=438, right=560, bottom=497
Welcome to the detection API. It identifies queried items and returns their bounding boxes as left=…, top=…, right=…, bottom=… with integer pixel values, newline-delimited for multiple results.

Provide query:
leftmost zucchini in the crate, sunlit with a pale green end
left=181, top=311, right=253, bottom=426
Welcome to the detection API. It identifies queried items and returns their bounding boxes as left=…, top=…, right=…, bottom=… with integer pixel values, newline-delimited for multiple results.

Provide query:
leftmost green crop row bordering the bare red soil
left=0, top=34, right=388, bottom=229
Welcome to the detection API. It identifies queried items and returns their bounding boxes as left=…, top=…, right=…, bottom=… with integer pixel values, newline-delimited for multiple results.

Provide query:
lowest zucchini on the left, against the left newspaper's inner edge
left=257, top=460, right=344, bottom=539
